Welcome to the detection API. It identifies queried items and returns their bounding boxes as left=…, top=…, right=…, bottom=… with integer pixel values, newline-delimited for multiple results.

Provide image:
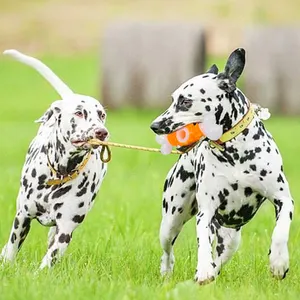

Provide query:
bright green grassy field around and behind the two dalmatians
left=0, top=55, right=300, bottom=300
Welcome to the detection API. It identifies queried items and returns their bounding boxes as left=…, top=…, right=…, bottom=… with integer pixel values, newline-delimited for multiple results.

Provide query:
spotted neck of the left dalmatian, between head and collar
left=46, top=127, right=88, bottom=175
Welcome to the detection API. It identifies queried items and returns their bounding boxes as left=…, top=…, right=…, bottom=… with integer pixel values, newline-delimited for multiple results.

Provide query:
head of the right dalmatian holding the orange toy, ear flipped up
left=151, top=48, right=245, bottom=140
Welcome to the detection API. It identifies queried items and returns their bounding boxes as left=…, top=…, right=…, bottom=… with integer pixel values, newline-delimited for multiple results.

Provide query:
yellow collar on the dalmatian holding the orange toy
left=209, top=104, right=255, bottom=151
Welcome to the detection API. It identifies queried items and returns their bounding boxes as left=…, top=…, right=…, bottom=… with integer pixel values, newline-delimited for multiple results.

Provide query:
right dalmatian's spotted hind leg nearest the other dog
left=160, top=154, right=197, bottom=275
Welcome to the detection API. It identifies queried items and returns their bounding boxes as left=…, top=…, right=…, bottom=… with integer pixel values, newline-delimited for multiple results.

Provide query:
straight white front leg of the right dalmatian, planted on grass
left=195, top=202, right=216, bottom=284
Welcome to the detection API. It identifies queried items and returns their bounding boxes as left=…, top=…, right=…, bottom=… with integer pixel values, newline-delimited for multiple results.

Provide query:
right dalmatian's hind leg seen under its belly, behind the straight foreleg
left=214, top=225, right=242, bottom=272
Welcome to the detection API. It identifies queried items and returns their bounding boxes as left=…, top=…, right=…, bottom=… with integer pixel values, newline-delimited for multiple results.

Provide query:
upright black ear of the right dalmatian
left=218, top=48, right=246, bottom=93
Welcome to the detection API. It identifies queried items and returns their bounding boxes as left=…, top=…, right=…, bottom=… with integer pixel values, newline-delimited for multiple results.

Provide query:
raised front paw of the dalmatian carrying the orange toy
left=270, top=247, right=289, bottom=279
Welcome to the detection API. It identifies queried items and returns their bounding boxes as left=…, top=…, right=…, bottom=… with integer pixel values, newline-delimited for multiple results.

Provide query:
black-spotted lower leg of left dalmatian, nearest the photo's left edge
left=0, top=211, right=31, bottom=261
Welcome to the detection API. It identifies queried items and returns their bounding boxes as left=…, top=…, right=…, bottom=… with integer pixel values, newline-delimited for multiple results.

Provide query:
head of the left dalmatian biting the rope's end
left=36, top=94, right=109, bottom=149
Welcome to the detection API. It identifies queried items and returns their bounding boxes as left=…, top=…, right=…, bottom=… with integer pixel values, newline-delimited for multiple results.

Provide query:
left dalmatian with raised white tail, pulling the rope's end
left=0, top=50, right=109, bottom=269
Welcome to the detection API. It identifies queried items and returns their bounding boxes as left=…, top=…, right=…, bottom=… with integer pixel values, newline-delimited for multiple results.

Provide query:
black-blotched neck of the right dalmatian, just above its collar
left=215, top=89, right=250, bottom=133
